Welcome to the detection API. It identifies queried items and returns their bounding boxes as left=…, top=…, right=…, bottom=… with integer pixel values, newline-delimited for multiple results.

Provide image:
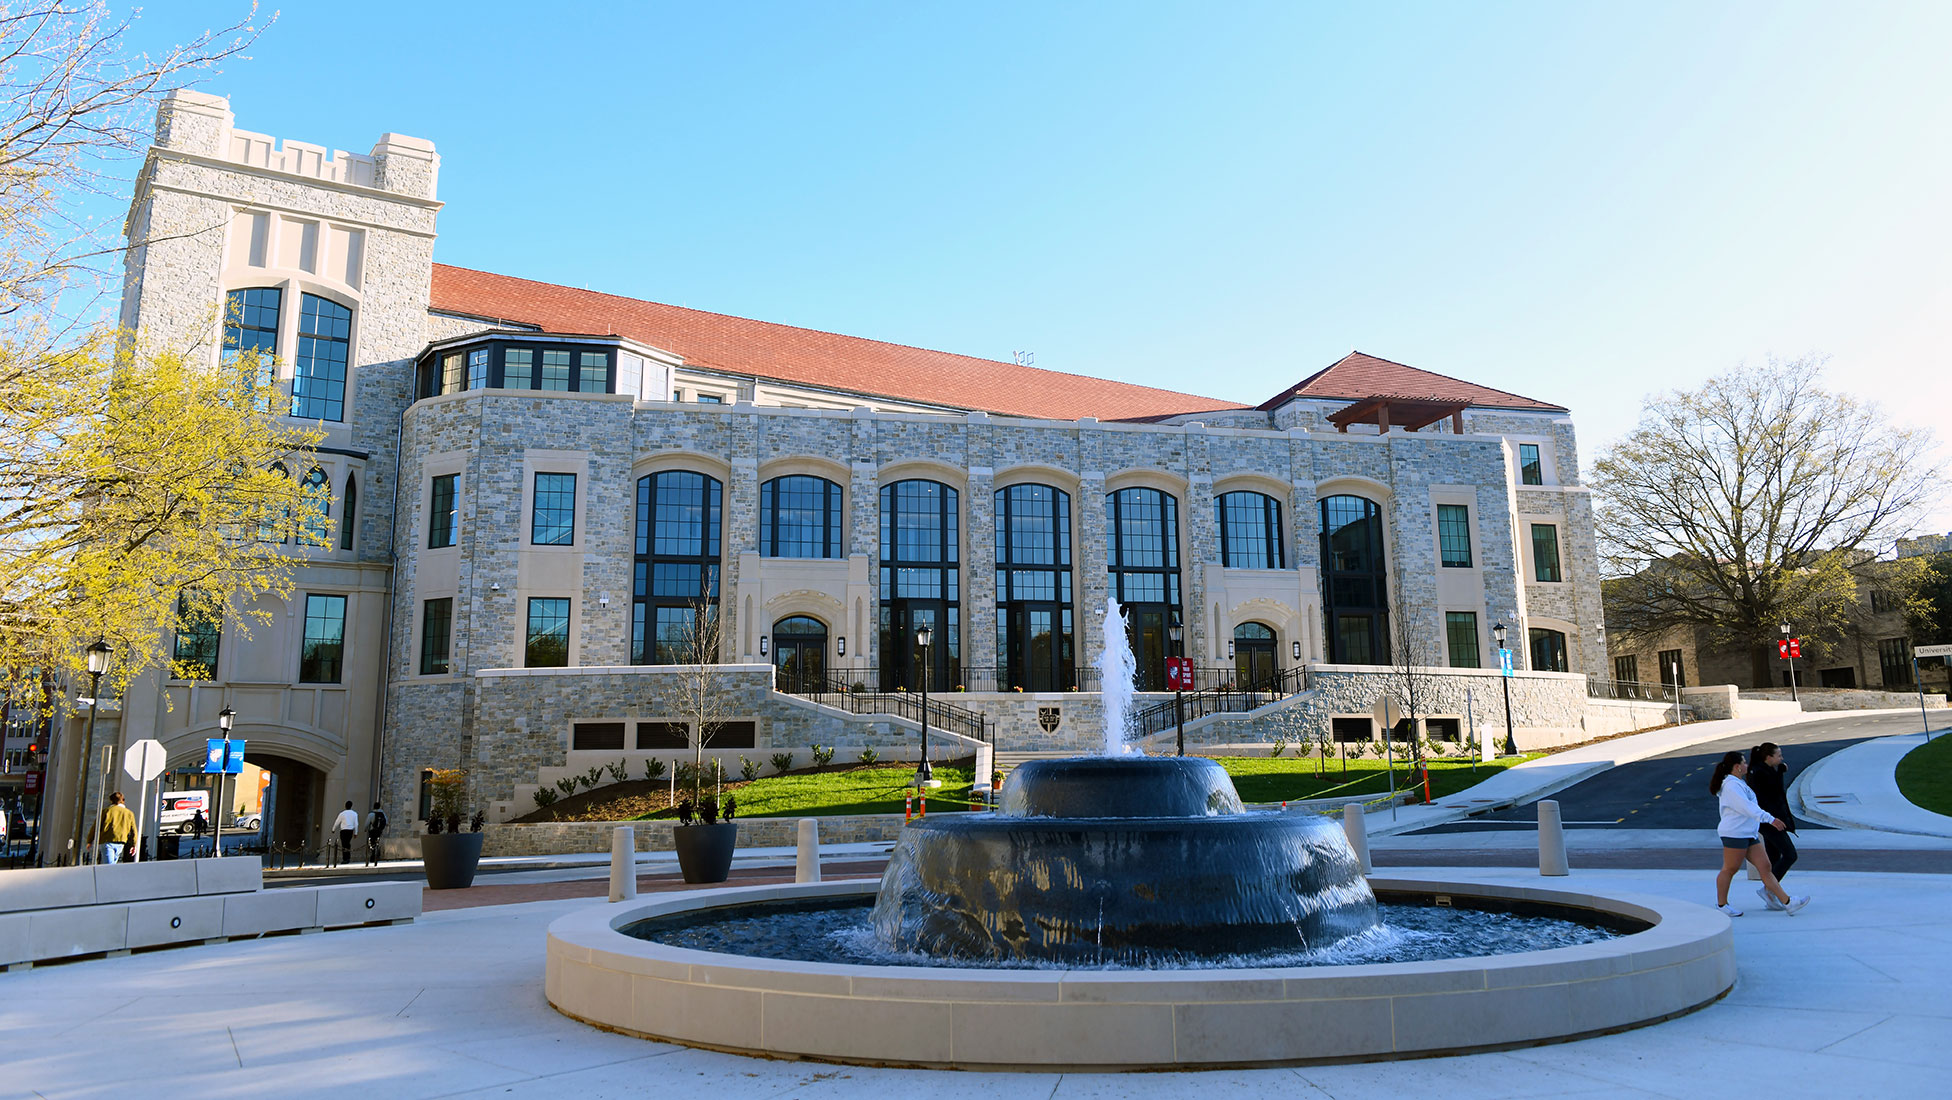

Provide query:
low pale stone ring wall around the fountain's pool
left=547, top=876, right=1735, bottom=1071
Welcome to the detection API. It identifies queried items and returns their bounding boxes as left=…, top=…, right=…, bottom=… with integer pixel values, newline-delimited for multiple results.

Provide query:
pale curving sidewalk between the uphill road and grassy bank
left=1364, top=710, right=1873, bottom=837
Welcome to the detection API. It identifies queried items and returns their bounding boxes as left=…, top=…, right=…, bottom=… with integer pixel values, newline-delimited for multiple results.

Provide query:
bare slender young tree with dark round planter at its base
left=671, top=601, right=738, bottom=884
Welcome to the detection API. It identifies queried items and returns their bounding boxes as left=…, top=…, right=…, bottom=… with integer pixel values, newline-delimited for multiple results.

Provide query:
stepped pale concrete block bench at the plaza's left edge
left=0, top=858, right=422, bottom=969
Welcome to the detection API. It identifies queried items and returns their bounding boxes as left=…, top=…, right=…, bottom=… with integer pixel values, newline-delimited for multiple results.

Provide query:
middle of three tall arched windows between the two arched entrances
left=996, top=486, right=1078, bottom=690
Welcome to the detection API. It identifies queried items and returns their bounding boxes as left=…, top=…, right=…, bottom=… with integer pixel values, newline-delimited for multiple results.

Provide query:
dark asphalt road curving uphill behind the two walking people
left=1423, top=714, right=1944, bottom=833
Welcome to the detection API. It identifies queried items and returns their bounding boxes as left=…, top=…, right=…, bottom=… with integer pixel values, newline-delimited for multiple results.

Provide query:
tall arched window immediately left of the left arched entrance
left=630, top=470, right=724, bottom=665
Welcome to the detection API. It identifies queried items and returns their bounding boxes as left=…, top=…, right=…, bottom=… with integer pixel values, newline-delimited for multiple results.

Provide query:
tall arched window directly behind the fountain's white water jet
left=1105, top=490, right=1179, bottom=690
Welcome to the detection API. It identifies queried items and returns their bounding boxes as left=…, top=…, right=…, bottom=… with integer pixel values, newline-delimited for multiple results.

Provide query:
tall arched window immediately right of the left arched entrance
left=878, top=480, right=962, bottom=690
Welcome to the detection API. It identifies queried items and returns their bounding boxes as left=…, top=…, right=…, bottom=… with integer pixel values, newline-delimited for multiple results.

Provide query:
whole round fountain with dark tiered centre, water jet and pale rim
left=547, top=603, right=1733, bottom=1069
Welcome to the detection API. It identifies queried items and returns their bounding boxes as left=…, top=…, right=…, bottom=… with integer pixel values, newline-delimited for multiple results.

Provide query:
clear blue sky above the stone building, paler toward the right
left=118, top=0, right=1952, bottom=530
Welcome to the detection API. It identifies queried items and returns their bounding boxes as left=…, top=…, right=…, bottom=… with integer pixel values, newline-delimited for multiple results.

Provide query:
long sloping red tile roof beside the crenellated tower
left=431, top=263, right=1247, bottom=419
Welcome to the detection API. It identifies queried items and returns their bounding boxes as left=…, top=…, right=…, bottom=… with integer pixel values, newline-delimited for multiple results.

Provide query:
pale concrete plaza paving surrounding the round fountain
left=0, top=868, right=1952, bottom=1100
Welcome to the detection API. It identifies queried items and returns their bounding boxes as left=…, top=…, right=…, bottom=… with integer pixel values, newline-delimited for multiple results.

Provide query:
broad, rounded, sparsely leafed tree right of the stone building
left=1593, top=359, right=1938, bottom=685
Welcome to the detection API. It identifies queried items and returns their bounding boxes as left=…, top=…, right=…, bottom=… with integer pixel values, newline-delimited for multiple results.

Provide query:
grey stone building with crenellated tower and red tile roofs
left=102, top=92, right=1605, bottom=837
